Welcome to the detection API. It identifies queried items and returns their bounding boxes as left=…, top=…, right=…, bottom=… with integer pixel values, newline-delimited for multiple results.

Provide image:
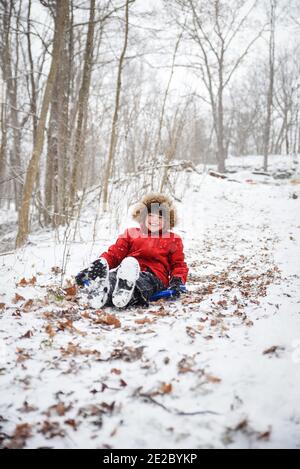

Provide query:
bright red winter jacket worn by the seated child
left=100, top=228, right=189, bottom=287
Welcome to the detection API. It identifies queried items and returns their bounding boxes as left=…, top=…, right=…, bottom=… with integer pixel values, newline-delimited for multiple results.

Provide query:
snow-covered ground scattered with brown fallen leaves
left=0, top=158, right=300, bottom=448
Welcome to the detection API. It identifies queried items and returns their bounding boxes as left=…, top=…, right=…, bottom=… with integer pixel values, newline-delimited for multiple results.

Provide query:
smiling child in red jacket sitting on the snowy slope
left=76, top=193, right=188, bottom=308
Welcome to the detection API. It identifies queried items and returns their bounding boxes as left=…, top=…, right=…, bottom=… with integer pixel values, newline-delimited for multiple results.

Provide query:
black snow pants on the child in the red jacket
left=106, top=269, right=166, bottom=307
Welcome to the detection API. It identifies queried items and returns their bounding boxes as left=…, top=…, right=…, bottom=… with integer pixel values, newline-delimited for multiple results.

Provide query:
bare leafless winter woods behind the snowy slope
left=0, top=0, right=300, bottom=247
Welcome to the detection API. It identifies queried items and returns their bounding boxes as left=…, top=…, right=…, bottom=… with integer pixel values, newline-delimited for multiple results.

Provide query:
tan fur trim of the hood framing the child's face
left=132, top=192, right=178, bottom=230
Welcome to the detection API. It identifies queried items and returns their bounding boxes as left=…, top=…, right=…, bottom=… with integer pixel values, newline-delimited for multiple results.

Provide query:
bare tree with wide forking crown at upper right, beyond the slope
left=166, top=0, right=263, bottom=172
